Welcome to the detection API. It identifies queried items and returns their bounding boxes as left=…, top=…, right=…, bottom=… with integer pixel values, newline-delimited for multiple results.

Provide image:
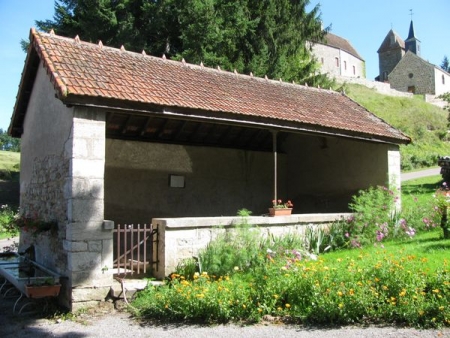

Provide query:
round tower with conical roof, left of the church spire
left=376, top=29, right=405, bottom=82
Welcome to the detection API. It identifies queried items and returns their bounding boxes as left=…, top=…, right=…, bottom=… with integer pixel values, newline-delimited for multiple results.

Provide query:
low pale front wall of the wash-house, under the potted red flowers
left=152, top=214, right=350, bottom=279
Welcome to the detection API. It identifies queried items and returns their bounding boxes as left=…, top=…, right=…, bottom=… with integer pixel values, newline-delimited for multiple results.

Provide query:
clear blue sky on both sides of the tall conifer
left=0, top=0, right=450, bottom=130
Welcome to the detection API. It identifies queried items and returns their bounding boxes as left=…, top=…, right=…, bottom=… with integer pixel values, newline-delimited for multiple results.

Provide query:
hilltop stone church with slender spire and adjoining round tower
left=376, top=21, right=450, bottom=96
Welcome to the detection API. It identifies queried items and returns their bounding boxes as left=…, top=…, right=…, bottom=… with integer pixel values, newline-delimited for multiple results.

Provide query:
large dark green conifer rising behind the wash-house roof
left=32, top=0, right=331, bottom=86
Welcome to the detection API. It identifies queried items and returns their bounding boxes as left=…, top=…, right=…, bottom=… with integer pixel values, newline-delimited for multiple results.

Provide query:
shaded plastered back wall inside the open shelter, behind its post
left=105, top=139, right=287, bottom=224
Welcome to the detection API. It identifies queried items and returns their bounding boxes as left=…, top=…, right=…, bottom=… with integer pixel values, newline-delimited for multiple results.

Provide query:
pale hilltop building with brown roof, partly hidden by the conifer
left=312, top=33, right=366, bottom=78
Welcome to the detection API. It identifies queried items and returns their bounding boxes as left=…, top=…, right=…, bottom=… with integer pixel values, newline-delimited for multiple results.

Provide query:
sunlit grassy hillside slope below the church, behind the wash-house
left=343, top=84, right=450, bottom=170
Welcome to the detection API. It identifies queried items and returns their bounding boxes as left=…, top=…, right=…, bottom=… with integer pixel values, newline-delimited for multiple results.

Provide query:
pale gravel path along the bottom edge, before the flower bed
left=0, top=298, right=450, bottom=338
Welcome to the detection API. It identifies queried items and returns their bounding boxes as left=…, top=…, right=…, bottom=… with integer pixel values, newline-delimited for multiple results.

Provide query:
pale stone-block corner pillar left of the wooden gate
left=64, top=108, right=113, bottom=309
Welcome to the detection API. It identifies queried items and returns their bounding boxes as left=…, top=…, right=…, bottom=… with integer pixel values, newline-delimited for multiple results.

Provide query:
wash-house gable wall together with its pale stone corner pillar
left=19, top=65, right=113, bottom=309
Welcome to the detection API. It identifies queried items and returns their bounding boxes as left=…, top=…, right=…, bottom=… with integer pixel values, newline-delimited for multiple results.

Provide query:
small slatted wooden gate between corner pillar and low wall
left=113, top=224, right=158, bottom=277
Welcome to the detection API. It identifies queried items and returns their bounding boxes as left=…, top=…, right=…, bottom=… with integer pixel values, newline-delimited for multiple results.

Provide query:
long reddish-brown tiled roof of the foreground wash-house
left=12, top=30, right=410, bottom=143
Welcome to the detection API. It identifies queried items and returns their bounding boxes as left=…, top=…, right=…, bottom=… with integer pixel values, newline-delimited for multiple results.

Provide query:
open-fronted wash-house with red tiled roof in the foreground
left=9, top=29, right=410, bottom=309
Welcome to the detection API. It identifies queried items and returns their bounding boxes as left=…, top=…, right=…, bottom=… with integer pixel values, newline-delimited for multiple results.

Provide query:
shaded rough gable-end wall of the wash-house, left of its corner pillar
left=19, top=65, right=72, bottom=305
